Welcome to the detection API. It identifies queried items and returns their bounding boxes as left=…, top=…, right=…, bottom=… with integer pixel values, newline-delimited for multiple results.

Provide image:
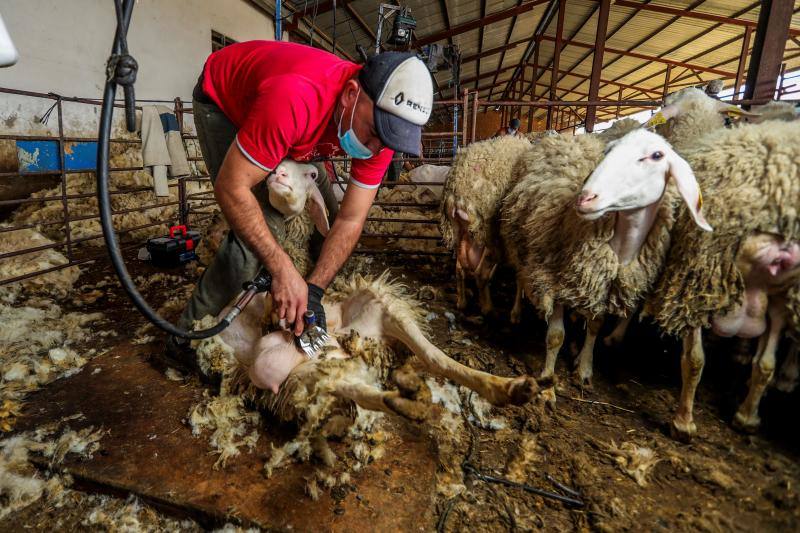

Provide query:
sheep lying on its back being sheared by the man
left=188, top=160, right=537, bottom=470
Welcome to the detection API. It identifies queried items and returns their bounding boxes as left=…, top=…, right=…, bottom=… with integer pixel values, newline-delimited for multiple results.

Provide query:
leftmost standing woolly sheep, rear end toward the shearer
left=439, top=135, right=531, bottom=314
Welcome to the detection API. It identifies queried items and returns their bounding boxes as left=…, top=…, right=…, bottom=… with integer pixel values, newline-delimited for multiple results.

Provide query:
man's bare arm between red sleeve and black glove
left=308, top=184, right=378, bottom=288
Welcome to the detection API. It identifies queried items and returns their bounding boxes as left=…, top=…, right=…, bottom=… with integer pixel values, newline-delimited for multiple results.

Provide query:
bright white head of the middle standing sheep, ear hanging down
left=576, top=129, right=711, bottom=231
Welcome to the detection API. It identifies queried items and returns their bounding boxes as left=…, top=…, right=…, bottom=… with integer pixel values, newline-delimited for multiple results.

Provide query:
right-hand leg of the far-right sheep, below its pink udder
left=733, top=308, right=786, bottom=433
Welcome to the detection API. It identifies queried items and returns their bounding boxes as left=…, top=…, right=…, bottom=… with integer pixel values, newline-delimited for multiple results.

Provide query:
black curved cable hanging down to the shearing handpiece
left=97, top=0, right=271, bottom=339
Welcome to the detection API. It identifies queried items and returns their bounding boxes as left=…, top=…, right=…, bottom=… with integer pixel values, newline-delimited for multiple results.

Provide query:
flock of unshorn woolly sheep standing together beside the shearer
left=440, top=88, right=800, bottom=438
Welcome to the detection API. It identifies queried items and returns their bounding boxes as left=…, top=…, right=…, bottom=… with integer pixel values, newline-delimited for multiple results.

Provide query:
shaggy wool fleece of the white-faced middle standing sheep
left=500, top=120, right=679, bottom=318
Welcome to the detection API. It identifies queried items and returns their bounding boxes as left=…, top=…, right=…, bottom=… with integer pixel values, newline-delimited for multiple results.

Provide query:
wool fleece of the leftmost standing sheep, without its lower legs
left=439, top=135, right=531, bottom=254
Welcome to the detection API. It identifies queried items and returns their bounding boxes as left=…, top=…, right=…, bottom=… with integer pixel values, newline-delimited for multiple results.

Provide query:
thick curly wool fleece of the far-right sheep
left=646, top=121, right=800, bottom=335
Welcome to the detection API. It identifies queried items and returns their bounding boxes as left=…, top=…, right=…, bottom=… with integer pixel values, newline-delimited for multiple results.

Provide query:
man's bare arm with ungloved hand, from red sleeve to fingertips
left=214, top=143, right=310, bottom=335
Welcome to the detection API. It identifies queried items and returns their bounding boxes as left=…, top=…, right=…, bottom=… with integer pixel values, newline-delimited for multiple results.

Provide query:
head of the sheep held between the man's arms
left=267, top=159, right=330, bottom=235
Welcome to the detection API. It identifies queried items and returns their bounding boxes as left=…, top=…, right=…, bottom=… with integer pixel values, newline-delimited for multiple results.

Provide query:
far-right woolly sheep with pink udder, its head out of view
left=640, top=121, right=800, bottom=438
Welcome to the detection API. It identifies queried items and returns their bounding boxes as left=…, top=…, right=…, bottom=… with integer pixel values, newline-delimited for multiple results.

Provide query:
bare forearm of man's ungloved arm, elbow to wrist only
left=214, top=186, right=291, bottom=272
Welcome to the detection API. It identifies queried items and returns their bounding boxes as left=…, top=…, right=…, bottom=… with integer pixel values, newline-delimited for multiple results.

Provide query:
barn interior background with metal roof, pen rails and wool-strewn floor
left=0, top=0, right=800, bottom=531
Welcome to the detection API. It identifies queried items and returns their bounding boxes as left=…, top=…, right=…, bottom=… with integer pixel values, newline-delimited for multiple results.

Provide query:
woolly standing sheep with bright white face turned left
left=501, top=121, right=708, bottom=383
